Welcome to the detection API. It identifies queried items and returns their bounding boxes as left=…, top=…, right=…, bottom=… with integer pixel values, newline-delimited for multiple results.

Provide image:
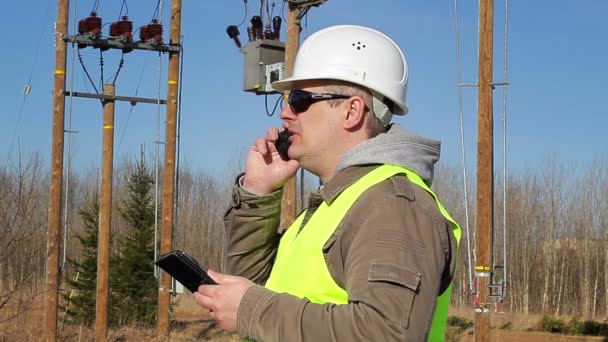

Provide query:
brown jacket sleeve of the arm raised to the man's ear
left=224, top=177, right=283, bottom=284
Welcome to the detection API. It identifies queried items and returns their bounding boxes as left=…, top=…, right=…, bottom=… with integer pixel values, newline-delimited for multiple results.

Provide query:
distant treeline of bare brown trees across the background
left=0, top=154, right=608, bottom=324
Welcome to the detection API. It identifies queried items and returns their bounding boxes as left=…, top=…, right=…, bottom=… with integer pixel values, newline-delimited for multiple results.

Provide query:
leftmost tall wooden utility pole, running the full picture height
left=46, top=0, right=70, bottom=341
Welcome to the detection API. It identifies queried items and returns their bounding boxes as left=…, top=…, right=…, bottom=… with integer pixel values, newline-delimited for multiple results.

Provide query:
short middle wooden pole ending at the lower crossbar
left=95, top=84, right=115, bottom=341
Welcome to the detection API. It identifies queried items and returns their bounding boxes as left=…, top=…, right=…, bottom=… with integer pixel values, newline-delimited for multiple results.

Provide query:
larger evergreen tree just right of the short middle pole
left=111, top=159, right=158, bottom=325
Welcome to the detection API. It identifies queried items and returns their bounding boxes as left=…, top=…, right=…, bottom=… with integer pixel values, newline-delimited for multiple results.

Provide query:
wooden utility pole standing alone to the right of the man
left=475, top=0, right=494, bottom=342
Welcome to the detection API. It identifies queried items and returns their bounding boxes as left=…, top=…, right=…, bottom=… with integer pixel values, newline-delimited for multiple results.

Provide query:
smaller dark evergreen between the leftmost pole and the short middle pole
left=62, top=193, right=99, bottom=326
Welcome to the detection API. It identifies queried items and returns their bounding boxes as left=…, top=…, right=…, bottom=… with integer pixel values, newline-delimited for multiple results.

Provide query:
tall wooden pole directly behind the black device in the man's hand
left=157, top=0, right=182, bottom=338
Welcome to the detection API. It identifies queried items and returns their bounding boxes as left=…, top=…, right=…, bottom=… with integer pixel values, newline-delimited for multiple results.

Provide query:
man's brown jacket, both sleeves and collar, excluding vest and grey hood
left=225, top=165, right=456, bottom=342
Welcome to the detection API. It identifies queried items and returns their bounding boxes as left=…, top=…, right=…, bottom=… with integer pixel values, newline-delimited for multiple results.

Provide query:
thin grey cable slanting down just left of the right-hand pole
left=454, top=0, right=474, bottom=293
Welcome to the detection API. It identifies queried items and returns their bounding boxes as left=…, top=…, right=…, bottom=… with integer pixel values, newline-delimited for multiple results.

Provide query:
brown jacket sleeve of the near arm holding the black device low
left=237, top=180, right=453, bottom=342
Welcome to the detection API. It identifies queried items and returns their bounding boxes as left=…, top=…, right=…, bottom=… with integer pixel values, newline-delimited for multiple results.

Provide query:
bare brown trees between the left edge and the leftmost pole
left=0, top=154, right=48, bottom=323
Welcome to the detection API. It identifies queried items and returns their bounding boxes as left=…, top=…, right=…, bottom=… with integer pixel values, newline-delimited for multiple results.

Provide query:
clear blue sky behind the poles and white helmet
left=0, top=0, right=608, bottom=177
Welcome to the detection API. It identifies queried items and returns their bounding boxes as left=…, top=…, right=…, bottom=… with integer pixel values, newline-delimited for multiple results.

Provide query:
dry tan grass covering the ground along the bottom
left=0, top=294, right=608, bottom=342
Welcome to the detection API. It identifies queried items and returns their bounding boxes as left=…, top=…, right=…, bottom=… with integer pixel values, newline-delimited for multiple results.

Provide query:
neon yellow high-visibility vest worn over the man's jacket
left=266, top=165, right=460, bottom=341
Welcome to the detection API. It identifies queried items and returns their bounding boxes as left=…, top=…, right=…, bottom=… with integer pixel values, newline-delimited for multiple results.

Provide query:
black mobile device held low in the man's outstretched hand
left=154, top=250, right=217, bottom=293
